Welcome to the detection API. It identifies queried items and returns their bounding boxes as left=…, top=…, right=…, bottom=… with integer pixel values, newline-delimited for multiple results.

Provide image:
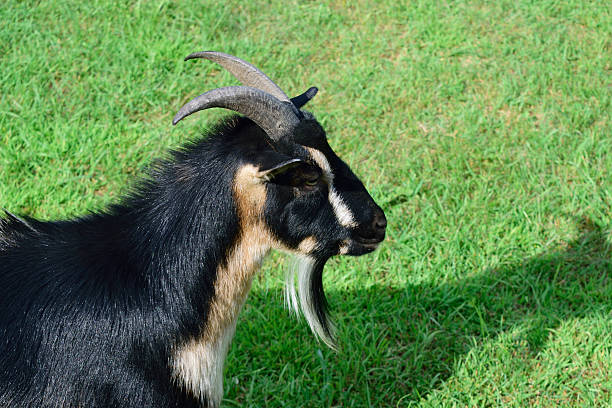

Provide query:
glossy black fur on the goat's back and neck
left=0, top=116, right=249, bottom=407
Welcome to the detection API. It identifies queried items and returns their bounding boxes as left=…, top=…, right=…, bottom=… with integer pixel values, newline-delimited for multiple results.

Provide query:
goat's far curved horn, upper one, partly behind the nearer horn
left=185, top=51, right=289, bottom=102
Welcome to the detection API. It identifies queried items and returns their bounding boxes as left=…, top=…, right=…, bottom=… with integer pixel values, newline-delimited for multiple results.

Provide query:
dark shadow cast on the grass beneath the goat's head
left=228, top=221, right=612, bottom=406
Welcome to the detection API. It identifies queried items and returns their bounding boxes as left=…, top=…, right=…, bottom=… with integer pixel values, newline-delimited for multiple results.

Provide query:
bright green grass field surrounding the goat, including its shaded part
left=0, top=0, right=612, bottom=407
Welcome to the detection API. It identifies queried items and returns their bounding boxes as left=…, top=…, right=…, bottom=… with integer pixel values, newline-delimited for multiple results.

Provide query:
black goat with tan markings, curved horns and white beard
left=0, top=51, right=386, bottom=407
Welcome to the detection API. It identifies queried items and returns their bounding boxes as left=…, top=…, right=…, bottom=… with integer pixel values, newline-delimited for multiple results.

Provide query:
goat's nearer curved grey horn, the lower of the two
left=172, top=86, right=299, bottom=141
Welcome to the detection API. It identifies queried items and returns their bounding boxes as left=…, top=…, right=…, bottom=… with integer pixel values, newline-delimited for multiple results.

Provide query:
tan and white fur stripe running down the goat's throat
left=172, top=165, right=277, bottom=406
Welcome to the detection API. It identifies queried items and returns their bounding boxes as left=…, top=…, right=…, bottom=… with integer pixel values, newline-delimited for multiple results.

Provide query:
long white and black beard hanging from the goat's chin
left=285, top=255, right=337, bottom=350
